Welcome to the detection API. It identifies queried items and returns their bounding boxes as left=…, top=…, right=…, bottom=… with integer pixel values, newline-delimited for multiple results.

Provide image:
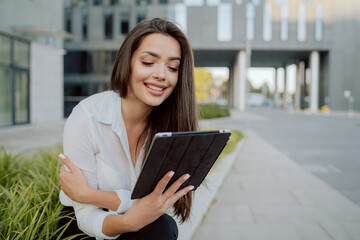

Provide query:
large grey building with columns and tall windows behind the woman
left=64, top=0, right=360, bottom=113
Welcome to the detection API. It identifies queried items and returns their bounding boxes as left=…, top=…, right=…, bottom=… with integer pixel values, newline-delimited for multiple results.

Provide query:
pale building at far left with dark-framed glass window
left=0, top=0, right=70, bottom=128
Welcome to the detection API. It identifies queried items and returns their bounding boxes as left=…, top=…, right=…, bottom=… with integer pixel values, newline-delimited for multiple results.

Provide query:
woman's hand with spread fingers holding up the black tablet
left=124, top=171, right=194, bottom=231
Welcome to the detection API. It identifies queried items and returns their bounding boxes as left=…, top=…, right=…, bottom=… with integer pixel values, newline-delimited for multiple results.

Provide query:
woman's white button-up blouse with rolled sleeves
left=60, top=91, right=144, bottom=239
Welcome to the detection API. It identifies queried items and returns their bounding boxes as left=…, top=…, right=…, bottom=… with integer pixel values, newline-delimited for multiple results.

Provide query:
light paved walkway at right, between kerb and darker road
left=192, top=132, right=360, bottom=240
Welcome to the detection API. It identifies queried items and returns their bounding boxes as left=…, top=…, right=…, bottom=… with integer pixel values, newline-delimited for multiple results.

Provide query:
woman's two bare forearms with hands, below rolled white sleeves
left=59, top=154, right=193, bottom=236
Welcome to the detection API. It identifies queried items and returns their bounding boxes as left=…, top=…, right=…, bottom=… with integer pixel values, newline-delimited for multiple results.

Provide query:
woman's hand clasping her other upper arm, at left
left=59, top=154, right=91, bottom=203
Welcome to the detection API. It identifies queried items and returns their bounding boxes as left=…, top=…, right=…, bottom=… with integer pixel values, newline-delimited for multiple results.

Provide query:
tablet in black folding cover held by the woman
left=131, top=129, right=231, bottom=199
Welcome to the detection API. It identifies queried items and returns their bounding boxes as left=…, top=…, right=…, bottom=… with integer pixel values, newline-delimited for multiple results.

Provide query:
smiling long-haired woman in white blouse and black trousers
left=59, top=18, right=197, bottom=239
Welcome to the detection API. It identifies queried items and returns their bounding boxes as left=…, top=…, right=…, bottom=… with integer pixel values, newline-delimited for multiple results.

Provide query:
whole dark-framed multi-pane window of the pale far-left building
left=0, top=32, right=30, bottom=127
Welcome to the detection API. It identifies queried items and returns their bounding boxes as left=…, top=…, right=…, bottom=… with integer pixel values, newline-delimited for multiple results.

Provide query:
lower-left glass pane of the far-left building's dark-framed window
left=0, top=66, right=12, bottom=126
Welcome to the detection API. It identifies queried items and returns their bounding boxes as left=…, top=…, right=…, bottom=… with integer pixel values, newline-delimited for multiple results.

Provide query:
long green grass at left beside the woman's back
left=0, top=147, right=81, bottom=240
